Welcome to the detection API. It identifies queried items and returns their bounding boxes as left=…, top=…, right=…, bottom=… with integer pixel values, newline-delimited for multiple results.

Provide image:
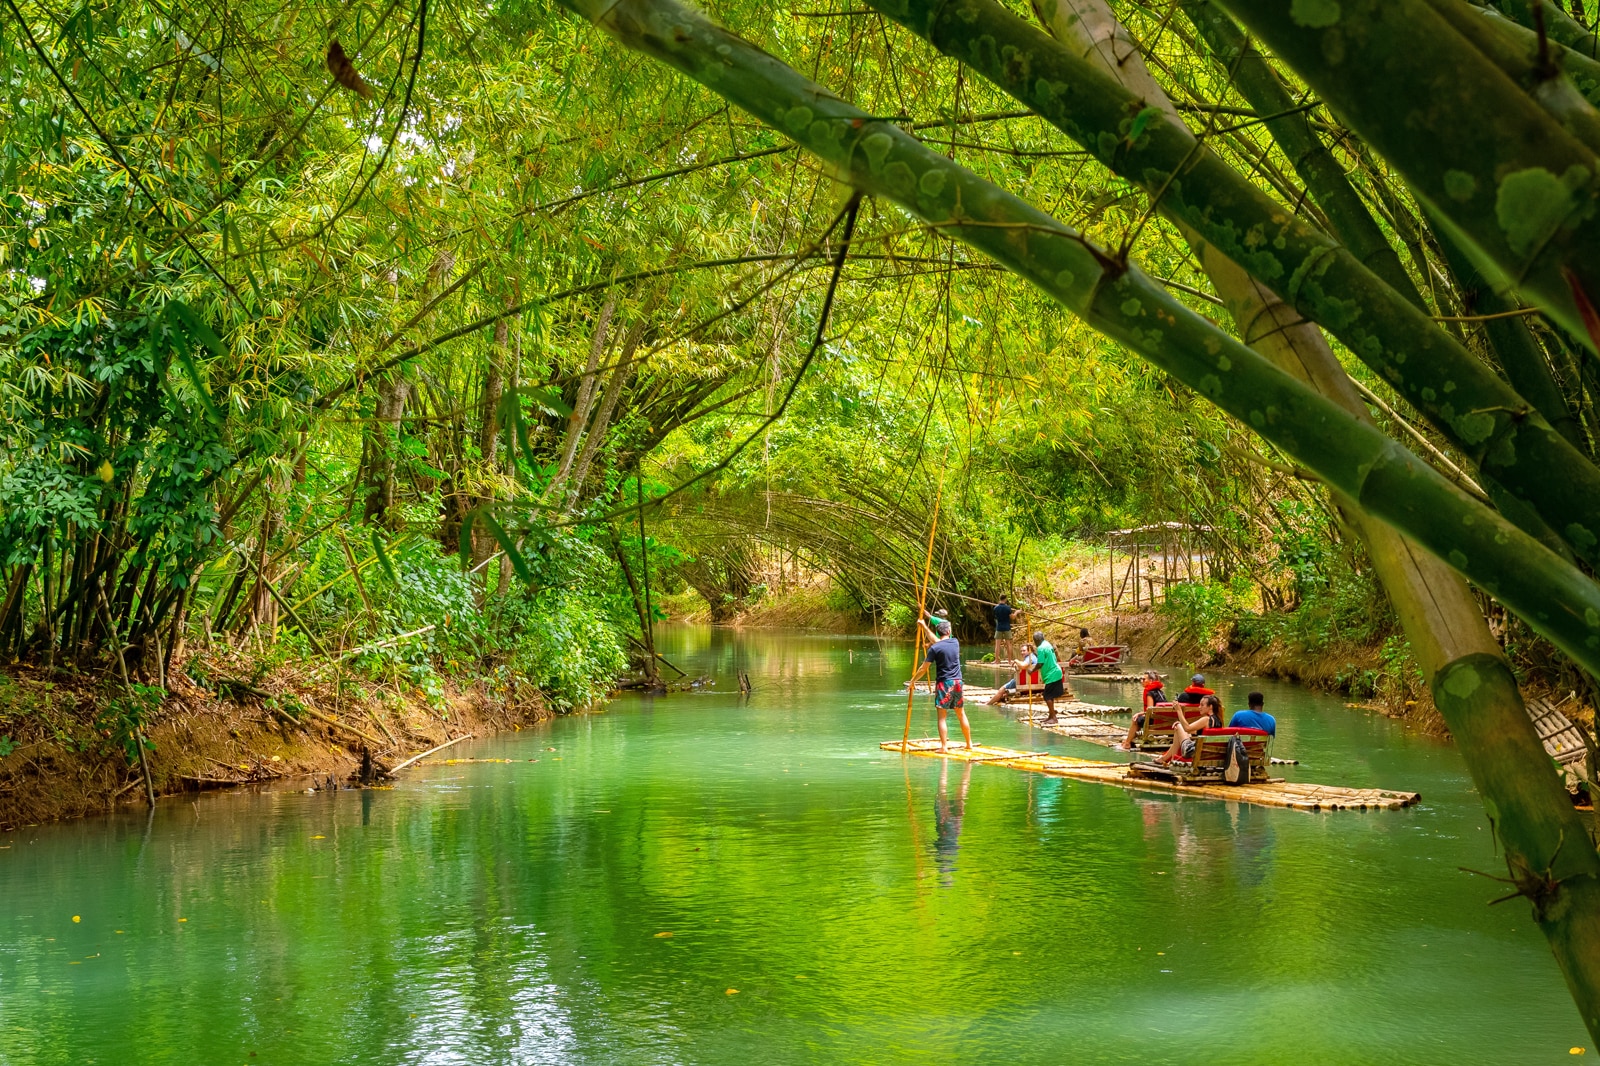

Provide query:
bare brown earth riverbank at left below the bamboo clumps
left=0, top=648, right=552, bottom=829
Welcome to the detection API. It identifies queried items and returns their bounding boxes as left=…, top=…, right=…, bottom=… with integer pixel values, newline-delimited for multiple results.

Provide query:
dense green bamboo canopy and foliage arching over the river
left=9, top=0, right=1600, bottom=1031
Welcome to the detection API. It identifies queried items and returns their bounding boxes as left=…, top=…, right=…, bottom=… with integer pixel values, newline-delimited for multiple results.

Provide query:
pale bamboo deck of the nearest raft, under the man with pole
left=878, top=739, right=1422, bottom=810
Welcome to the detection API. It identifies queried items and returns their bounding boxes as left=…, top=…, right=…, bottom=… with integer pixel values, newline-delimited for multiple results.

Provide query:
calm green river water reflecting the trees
left=0, top=627, right=1594, bottom=1064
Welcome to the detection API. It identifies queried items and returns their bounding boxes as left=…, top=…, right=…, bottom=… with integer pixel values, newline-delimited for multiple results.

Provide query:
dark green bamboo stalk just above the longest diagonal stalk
left=869, top=0, right=1600, bottom=562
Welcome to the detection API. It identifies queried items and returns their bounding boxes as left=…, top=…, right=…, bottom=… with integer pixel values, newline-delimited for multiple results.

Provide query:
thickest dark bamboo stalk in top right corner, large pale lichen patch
left=1218, top=0, right=1600, bottom=356
